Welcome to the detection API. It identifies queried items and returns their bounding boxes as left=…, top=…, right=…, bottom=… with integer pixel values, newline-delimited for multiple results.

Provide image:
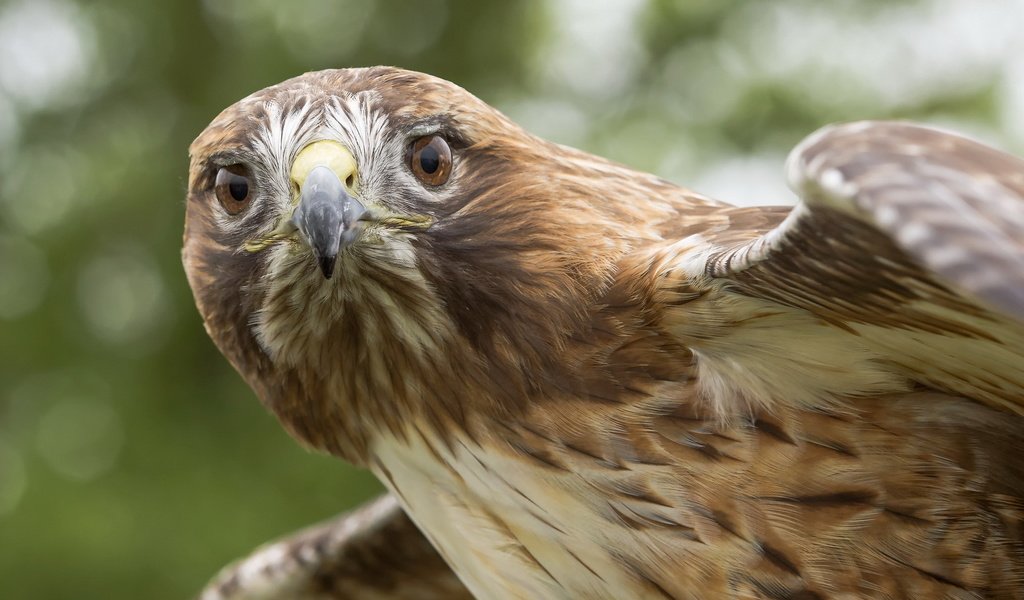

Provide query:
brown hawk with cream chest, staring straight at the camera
left=183, top=68, right=1024, bottom=600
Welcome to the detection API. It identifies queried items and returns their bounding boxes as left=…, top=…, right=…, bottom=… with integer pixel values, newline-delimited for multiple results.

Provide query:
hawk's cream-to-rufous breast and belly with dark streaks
left=374, top=388, right=1024, bottom=598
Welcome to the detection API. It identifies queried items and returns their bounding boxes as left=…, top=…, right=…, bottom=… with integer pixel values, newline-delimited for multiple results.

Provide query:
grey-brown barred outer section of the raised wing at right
left=788, top=122, right=1024, bottom=319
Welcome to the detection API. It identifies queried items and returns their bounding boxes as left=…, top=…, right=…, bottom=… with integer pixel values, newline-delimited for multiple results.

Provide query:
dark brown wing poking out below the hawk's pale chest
left=199, top=496, right=472, bottom=600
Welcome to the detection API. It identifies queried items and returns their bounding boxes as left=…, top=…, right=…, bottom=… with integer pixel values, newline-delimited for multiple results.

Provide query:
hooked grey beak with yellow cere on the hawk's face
left=292, top=140, right=367, bottom=280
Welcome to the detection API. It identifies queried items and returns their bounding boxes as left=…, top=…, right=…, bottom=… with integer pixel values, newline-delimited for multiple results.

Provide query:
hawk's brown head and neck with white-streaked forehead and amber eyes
left=183, top=68, right=696, bottom=458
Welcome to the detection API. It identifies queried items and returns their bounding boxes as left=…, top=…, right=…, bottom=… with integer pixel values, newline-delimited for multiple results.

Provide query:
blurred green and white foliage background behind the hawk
left=0, top=0, right=1024, bottom=599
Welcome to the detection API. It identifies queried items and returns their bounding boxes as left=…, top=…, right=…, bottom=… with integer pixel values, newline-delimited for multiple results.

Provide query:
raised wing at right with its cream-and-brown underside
left=651, top=122, right=1024, bottom=414
